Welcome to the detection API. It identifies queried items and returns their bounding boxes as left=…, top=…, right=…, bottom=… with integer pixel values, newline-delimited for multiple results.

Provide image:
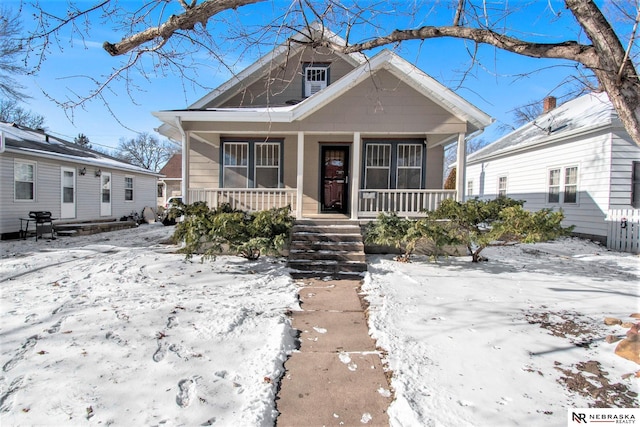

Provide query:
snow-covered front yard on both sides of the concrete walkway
left=0, top=224, right=640, bottom=426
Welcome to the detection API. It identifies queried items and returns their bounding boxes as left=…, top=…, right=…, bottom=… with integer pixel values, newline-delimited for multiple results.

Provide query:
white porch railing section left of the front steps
left=189, top=188, right=297, bottom=212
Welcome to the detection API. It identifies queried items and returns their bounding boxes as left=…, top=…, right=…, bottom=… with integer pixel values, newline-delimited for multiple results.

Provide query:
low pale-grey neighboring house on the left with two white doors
left=0, top=123, right=161, bottom=238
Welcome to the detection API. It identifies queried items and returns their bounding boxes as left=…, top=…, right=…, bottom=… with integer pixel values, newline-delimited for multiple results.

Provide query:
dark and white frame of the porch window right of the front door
left=360, top=138, right=427, bottom=191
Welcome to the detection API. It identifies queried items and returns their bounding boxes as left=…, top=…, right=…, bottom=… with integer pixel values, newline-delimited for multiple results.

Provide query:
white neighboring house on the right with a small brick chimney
left=466, top=93, right=640, bottom=247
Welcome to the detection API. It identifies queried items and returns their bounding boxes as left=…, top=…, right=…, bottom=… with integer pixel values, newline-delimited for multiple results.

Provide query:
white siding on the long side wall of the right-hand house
left=466, top=127, right=611, bottom=241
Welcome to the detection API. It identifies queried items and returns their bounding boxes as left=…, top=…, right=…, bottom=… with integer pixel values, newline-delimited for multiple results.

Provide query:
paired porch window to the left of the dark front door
left=221, top=140, right=282, bottom=188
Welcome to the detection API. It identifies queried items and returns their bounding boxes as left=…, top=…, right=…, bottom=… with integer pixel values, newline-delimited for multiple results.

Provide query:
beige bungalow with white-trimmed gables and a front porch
left=153, top=24, right=492, bottom=220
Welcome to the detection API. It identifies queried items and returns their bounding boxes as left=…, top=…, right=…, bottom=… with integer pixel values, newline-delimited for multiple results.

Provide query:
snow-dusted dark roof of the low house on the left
left=0, top=122, right=159, bottom=176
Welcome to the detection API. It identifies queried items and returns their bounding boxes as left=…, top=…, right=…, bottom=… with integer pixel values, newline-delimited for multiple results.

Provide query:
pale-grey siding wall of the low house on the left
left=0, top=152, right=157, bottom=234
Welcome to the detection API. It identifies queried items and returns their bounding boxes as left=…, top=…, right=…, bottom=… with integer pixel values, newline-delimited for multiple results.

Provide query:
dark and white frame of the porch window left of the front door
left=218, top=138, right=284, bottom=189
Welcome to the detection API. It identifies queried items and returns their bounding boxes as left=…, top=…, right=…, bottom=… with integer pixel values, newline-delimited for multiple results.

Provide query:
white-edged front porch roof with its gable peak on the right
left=152, top=49, right=493, bottom=139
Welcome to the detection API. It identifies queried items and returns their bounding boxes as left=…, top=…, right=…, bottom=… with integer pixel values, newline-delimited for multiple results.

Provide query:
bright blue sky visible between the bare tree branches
left=2, top=0, right=616, bottom=149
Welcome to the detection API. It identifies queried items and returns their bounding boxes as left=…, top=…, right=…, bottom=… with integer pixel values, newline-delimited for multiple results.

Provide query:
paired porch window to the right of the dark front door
left=362, top=140, right=425, bottom=189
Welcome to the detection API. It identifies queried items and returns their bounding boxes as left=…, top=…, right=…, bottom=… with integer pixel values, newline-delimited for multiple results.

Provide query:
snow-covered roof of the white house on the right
left=467, top=92, right=618, bottom=164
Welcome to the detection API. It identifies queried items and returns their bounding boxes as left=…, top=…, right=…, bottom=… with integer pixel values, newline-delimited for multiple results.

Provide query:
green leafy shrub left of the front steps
left=174, top=202, right=293, bottom=260
